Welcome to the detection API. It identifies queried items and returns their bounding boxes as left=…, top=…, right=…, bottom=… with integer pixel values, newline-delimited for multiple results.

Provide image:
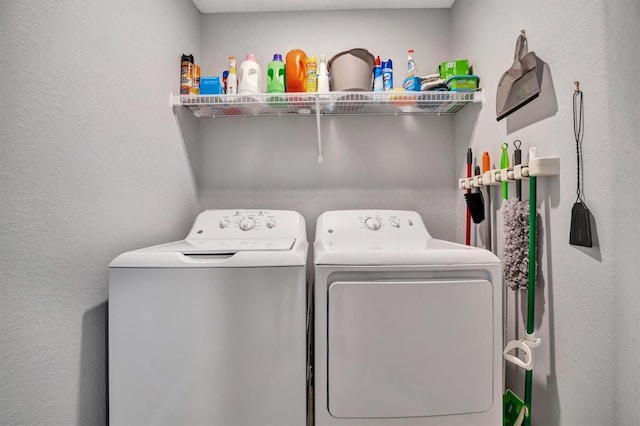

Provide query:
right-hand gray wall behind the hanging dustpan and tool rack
left=452, top=0, right=640, bottom=425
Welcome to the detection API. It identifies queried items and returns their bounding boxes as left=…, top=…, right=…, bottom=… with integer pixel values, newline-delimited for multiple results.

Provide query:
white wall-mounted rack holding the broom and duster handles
left=458, top=157, right=560, bottom=190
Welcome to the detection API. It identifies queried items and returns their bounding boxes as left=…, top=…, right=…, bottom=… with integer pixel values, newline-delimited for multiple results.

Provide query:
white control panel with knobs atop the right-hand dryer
left=316, top=210, right=431, bottom=250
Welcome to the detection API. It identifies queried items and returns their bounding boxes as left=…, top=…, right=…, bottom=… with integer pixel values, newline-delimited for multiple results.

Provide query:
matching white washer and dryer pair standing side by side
left=109, top=210, right=503, bottom=425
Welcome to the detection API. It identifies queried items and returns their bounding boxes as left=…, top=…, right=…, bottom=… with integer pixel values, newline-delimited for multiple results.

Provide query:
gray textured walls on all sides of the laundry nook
left=0, top=0, right=640, bottom=425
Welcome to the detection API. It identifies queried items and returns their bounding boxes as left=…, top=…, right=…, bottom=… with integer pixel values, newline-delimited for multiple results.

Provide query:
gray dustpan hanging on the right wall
left=496, top=34, right=544, bottom=121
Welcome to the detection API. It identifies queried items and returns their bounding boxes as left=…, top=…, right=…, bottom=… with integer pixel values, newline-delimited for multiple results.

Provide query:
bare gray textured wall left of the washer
left=0, top=0, right=199, bottom=424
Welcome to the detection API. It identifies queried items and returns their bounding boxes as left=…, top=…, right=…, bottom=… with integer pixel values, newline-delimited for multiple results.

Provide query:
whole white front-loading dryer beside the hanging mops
left=314, top=210, right=503, bottom=426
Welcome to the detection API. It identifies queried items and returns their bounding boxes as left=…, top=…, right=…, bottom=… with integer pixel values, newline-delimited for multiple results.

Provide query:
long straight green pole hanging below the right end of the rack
left=524, top=176, right=537, bottom=426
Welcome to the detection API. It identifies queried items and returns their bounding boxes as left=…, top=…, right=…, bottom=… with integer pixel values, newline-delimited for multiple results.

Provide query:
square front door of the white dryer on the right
left=327, top=280, right=492, bottom=418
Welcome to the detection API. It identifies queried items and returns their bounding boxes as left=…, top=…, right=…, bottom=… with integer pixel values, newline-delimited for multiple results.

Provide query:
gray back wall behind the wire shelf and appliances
left=198, top=9, right=464, bottom=239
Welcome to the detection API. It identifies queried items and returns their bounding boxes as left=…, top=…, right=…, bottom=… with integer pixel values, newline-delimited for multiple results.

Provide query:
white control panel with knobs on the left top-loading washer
left=187, top=209, right=306, bottom=241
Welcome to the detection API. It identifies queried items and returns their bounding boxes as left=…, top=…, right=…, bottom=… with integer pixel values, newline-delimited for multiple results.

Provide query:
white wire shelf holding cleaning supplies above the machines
left=171, top=90, right=484, bottom=117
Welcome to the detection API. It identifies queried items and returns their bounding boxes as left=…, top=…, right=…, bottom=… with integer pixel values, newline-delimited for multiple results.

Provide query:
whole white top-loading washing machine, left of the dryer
left=109, top=210, right=308, bottom=426
